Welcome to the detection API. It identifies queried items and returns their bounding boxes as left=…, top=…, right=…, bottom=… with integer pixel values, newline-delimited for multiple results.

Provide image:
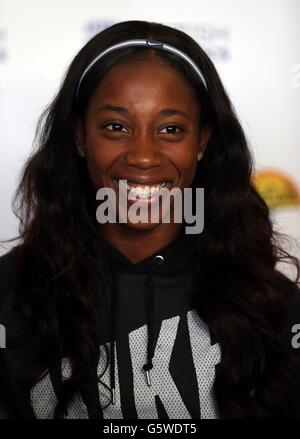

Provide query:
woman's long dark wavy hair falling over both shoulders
left=5, top=21, right=299, bottom=418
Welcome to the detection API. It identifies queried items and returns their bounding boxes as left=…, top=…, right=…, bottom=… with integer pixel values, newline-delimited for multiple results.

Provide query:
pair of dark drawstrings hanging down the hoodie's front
left=110, top=255, right=164, bottom=404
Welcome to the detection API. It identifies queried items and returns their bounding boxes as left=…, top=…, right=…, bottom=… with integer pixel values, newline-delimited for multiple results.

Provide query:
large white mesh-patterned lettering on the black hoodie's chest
left=31, top=310, right=221, bottom=419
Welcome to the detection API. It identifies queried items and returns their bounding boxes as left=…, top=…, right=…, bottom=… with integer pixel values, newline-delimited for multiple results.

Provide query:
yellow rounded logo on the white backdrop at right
left=252, top=169, right=300, bottom=208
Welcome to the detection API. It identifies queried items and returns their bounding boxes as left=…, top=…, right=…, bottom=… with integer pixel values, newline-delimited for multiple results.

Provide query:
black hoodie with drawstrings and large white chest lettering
left=0, top=234, right=300, bottom=419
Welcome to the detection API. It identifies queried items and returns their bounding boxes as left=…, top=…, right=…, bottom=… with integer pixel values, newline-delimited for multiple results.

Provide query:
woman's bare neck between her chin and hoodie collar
left=100, top=223, right=182, bottom=263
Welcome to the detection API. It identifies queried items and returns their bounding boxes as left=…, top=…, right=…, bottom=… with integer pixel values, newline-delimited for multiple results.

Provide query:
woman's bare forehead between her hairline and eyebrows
left=90, top=58, right=199, bottom=111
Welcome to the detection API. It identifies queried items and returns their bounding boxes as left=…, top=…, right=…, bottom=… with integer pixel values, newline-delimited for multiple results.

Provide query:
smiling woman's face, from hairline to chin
left=77, top=52, right=209, bottom=242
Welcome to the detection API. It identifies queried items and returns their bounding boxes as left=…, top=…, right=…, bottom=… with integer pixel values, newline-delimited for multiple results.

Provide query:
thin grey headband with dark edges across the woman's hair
left=75, top=40, right=207, bottom=99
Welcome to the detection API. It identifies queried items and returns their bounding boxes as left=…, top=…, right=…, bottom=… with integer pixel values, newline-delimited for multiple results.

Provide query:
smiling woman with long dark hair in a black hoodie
left=0, top=21, right=300, bottom=419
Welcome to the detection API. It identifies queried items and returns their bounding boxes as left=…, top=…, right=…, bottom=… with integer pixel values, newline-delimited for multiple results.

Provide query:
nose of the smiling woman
left=124, top=139, right=162, bottom=170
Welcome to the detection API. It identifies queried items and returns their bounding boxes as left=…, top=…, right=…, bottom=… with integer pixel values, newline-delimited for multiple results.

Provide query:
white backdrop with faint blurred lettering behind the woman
left=0, top=0, right=300, bottom=276
